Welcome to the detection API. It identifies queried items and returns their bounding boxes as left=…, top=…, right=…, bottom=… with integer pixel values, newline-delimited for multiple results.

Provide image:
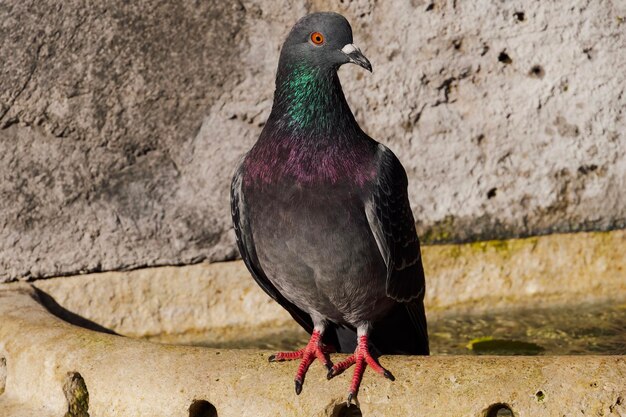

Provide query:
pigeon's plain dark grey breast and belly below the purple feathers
left=246, top=180, right=393, bottom=325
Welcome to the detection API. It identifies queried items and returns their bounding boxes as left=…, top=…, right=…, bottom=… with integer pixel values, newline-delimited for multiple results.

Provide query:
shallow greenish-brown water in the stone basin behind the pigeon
left=157, top=304, right=626, bottom=355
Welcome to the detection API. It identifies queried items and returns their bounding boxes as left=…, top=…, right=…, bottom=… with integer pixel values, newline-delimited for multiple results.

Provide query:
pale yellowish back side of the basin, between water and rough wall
left=28, top=230, right=626, bottom=340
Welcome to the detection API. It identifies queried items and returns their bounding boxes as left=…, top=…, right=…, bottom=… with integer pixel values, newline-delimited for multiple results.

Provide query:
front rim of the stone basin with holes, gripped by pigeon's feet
left=0, top=284, right=626, bottom=417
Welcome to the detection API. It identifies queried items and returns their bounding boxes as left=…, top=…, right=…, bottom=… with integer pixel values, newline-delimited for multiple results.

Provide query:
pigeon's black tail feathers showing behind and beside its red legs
left=324, top=298, right=430, bottom=355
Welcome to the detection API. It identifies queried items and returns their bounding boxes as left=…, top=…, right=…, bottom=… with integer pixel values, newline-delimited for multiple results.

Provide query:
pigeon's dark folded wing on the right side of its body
left=366, top=145, right=424, bottom=303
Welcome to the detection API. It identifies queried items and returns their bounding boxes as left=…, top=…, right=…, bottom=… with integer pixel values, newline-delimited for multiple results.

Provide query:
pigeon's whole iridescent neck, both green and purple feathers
left=246, top=65, right=376, bottom=185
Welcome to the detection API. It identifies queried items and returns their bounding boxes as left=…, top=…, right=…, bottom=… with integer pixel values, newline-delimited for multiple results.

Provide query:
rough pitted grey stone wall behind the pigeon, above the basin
left=0, top=0, right=626, bottom=281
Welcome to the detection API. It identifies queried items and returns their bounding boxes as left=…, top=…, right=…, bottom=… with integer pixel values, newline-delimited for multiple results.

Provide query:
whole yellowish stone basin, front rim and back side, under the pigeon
left=0, top=231, right=626, bottom=417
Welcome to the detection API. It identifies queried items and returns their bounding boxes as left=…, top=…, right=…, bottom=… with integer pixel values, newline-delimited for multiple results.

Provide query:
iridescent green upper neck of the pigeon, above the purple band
left=269, top=64, right=359, bottom=136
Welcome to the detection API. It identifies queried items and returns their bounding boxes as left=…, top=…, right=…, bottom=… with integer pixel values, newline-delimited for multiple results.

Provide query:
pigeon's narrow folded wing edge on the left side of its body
left=230, top=160, right=313, bottom=333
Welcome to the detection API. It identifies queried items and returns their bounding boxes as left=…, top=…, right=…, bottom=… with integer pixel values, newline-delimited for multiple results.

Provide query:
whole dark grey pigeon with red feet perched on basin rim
left=231, top=12, right=429, bottom=404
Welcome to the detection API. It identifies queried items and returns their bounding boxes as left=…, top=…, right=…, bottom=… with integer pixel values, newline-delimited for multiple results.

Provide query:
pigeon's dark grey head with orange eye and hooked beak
left=281, top=12, right=372, bottom=71
